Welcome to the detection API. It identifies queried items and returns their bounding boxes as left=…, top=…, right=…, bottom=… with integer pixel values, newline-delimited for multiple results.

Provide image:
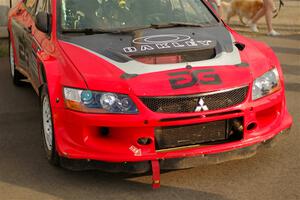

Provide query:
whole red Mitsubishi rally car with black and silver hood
left=8, top=0, right=292, bottom=187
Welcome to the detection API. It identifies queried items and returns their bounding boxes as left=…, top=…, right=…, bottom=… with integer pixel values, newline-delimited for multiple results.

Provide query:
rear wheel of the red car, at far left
left=9, top=42, right=24, bottom=86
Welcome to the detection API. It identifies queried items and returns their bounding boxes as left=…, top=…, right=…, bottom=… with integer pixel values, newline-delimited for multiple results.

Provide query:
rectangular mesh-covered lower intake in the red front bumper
left=155, top=118, right=243, bottom=150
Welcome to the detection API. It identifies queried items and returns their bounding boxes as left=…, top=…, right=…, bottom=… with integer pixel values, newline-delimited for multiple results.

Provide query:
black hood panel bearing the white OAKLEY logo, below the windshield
left=61, top=24, right=233, bottom=63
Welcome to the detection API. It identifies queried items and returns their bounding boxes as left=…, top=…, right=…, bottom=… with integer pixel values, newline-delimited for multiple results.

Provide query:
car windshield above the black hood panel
left=60, top=0, right=217, bottom=33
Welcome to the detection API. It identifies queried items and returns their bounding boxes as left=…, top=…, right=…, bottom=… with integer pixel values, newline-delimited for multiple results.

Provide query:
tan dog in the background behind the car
left=221, top=0, right=263, bottom=25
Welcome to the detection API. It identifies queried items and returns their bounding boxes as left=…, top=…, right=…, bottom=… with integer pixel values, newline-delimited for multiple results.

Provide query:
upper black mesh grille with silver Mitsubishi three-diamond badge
left=140, top=86, right=248, bottom=113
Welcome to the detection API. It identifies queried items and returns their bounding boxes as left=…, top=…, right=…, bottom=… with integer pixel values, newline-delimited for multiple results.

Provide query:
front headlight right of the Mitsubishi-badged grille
left=252, top=68, right=281, bottom=100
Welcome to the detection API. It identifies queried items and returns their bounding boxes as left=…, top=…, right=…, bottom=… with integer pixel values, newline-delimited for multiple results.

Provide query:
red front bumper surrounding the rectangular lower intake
left=53, top=91, right=292, bottom=166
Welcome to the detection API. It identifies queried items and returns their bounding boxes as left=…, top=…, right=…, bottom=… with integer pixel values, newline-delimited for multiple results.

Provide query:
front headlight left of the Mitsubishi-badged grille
left=64, top=87, right=138, bottom=114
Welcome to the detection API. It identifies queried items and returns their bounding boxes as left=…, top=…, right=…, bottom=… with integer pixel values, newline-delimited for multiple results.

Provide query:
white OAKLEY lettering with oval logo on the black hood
left=123, top=34, right=213, bottom=53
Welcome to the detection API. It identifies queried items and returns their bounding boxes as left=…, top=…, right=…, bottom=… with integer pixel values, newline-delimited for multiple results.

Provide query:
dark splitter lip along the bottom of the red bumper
left=61, top=128, right=290, bottom=173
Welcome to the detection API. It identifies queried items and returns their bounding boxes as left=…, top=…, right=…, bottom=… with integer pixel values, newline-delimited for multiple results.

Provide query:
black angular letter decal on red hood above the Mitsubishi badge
left=169, top=68, right=222, bottom=90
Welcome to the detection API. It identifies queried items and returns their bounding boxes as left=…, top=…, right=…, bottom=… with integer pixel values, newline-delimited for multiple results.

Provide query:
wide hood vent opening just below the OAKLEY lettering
left=130, top=48, right=216, bottom=64
